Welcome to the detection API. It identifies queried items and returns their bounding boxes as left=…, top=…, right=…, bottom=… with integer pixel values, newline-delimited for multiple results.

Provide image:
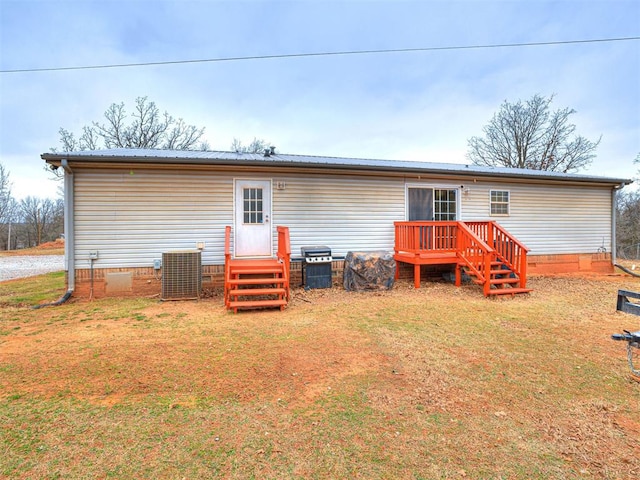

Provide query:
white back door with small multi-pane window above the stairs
left=234, top=179, right=272, bottom=257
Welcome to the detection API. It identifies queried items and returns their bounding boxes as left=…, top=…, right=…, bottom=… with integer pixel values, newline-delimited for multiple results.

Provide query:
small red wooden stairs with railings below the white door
left=224, top=227, right=291, bottom=313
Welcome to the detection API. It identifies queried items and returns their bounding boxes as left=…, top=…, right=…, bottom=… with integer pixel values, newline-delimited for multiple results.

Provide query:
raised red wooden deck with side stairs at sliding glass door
left=394, top=221, right=531, bottom=297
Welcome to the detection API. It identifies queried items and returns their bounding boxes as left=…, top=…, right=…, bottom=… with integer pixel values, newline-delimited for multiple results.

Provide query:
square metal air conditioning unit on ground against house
left=162, top=250, right=202, bottom=300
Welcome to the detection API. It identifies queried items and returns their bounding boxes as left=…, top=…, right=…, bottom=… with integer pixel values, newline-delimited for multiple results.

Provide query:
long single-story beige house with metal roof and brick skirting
left=41, top=149, right=630, bottom=308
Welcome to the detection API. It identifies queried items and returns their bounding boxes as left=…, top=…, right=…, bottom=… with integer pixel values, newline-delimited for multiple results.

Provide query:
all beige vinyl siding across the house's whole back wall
left=73, top=169, right=611, bottom=268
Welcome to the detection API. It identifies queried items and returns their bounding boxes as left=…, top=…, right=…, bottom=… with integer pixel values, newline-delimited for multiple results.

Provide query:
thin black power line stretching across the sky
left=0, top=37, right=640, bottom=73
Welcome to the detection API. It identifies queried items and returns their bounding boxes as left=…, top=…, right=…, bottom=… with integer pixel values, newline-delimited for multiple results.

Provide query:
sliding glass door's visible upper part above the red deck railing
left=407, top=187, right=458, bottom=222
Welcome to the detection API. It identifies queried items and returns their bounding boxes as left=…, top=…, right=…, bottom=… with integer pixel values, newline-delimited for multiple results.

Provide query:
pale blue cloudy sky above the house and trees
left=0, top=0, right=640, bottom=199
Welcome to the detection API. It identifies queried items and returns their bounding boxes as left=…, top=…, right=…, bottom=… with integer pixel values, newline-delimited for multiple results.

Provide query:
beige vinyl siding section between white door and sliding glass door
left=273, top=175, right=404, bottom=256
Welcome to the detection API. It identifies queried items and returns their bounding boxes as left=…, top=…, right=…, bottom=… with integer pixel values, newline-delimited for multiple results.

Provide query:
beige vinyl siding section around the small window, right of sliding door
left=461, top=182, right=611, bottom=255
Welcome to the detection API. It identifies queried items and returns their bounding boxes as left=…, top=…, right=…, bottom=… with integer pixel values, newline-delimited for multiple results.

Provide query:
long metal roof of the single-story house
left=41, top=148, right=632, bottom=185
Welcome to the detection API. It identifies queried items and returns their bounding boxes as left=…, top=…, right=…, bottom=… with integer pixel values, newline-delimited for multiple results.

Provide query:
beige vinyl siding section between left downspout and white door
left=73, top=170, right=233, bottom=268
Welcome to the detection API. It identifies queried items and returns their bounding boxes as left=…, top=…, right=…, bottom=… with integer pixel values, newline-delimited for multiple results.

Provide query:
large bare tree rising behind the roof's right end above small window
left=467, top=95, right=600, bottom=173
